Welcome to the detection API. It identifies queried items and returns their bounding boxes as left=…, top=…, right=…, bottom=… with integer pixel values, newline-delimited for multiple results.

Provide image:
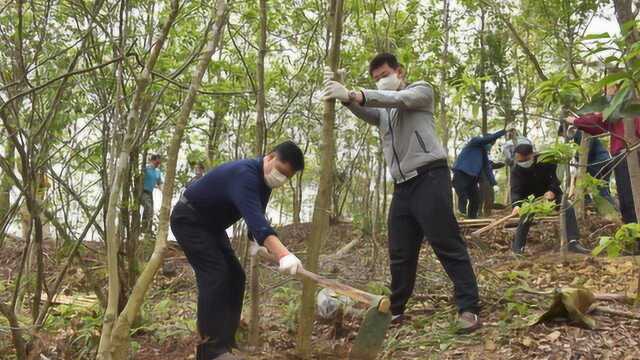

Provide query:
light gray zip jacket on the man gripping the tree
left=346, top=81, right=447, bottom=183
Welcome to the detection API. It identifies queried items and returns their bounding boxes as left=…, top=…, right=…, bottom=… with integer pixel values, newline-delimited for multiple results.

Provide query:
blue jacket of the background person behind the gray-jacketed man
left=453, top=130, right=507, bottom=185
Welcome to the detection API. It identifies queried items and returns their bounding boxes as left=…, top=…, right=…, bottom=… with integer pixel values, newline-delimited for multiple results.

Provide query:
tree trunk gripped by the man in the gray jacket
left=297, top=0, right=343, bottom=358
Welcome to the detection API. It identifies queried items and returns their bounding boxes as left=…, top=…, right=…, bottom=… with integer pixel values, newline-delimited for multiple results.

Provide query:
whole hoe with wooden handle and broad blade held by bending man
left=258, top=250, right=391, bottom=360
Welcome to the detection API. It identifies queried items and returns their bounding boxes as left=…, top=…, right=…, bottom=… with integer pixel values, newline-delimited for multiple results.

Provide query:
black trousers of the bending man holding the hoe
left=171, top=202, right=246, bottom=360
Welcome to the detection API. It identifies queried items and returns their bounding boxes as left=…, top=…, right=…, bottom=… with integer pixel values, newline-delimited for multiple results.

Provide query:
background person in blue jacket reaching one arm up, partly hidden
left=453, top=130, right=507, bottom=219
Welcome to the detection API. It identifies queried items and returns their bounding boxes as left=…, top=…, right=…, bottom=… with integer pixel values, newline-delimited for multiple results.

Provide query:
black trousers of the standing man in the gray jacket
left=389, top=167, right=479, bottom=315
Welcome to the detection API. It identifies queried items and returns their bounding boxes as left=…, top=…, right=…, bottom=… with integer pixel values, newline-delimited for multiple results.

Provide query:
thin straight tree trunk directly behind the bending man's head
left=249, top=0, right=267, bottom=348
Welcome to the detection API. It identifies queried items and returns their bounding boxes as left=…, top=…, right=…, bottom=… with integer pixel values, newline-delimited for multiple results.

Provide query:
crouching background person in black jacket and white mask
left=511, top=137, right=591, bottom=255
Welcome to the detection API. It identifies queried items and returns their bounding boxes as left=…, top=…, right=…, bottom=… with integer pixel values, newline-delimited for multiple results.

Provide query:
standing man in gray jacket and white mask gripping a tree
left=323, top=53, right=481, bottom=332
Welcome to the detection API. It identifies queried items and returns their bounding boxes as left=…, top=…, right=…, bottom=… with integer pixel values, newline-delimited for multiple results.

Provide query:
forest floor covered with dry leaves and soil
left=0, top=210, right=640, bottom=360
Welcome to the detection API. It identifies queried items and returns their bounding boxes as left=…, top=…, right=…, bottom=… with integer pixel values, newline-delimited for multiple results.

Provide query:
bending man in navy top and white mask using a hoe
left=171, top=141, right=304, bottom=360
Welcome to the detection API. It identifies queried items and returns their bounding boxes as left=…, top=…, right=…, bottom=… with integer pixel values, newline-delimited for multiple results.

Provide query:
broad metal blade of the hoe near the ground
left=349, top=306, right=391, bottom=360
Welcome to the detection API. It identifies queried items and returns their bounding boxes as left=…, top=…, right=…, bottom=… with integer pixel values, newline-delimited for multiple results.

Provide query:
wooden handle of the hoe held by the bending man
left=258, top=251, right=391, bottom=313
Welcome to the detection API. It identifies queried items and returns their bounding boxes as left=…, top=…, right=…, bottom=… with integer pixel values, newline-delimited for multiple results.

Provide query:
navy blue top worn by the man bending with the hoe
left=184, top=158, right=277, bottom=245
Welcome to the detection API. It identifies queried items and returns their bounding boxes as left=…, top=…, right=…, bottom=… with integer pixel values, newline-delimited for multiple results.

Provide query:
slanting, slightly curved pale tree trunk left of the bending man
left=109, top=0, right=226, bottom=360
